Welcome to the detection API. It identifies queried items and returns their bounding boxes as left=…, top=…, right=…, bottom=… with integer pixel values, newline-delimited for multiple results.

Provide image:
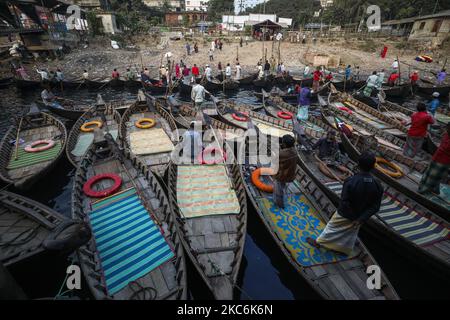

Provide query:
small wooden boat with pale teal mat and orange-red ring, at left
left=66, top=104, right=121, bottom=168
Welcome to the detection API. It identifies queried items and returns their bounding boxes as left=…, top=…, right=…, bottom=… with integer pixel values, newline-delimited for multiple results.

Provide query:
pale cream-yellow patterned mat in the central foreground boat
left=177, top=165, right=240, bottom=218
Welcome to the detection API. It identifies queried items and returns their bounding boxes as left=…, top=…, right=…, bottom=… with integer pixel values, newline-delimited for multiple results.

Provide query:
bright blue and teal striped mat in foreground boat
left=89, top=188, right=174, bottom=295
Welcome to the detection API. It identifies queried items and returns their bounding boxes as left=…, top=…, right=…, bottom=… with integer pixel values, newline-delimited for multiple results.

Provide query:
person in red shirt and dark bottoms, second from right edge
left=403, top=102, right=434, bottom=158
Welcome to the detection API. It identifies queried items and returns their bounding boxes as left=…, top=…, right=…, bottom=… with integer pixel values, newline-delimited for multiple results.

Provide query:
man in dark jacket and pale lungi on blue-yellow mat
left=306, top=152, right=384, bottom=255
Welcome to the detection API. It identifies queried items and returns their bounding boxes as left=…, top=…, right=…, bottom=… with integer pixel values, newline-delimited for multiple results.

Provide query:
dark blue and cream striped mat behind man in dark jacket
left=326, top=182, right=450, bottom=246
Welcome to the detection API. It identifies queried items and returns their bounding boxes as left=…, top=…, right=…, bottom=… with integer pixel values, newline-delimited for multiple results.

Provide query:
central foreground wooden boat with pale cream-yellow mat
left=168, top=127, right=247, bottom=300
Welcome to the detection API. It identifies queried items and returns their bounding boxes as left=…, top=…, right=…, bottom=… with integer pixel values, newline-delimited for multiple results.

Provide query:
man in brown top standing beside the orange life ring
left=273, top=134, right=297, bottom=208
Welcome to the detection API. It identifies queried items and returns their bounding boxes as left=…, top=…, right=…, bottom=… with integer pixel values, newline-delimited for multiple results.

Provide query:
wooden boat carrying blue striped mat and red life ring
left=72, top=134, right=187, bottom=300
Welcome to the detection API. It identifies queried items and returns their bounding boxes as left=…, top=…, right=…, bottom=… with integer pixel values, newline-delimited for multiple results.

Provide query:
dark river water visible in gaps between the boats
left=0, top=87, right=450, bottom=300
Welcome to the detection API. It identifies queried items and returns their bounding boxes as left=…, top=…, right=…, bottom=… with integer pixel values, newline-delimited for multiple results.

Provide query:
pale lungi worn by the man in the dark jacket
left=316, top=211, right=360, bottom=255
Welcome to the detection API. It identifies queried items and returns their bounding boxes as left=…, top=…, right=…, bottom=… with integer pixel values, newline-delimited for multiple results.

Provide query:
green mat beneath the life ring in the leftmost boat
left=7, top=140, right=62, bottom=170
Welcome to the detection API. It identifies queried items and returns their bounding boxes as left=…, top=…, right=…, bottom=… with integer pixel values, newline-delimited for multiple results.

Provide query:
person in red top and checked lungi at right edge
left=418, top=122, right=450, bottom=195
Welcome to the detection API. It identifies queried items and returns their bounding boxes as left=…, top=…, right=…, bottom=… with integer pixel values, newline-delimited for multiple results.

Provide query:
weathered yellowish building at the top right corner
left=408, top=10, right=450, bottom=47
